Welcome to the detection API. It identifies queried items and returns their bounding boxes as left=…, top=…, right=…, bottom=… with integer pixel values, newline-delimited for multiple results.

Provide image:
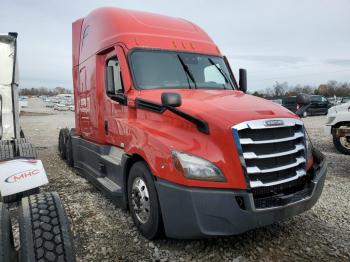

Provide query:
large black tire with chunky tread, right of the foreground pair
left=19, top=192, right=75, bottom=262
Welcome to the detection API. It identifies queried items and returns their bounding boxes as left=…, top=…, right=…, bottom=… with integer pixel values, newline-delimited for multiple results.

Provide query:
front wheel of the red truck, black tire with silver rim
left=128, top=162, right=162, bottom=239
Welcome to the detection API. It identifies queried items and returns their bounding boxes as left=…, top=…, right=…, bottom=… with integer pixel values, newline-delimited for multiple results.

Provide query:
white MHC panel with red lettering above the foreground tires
left=0, top=159, right=49, bottom=196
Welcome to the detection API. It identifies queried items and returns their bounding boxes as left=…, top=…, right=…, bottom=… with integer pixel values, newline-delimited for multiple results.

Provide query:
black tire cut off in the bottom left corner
left=0, top=203, right=17, bottom=262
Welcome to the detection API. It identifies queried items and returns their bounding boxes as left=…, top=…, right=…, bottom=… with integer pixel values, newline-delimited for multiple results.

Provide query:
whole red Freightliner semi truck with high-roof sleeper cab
left=59, top=8, right=326, bottom=239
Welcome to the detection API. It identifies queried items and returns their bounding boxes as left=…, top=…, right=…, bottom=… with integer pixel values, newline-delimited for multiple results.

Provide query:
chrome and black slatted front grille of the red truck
left=232, top=118, right=306, bottom=188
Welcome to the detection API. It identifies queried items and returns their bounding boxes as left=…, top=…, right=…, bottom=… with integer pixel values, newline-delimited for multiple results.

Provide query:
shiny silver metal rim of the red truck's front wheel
left=131, top=177, right=151, bottom=224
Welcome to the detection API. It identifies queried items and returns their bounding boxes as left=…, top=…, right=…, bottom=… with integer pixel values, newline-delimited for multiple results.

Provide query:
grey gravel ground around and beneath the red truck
left=21, top=99, right=350, bottom=262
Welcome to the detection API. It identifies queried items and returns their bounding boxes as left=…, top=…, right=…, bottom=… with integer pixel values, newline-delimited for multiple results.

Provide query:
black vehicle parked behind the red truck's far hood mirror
left=282, top=95, right=332, bottom=115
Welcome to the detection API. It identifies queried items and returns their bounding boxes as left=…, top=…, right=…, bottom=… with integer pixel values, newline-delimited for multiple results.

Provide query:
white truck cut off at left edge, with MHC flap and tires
left=0, top=33, right=75, bottom=262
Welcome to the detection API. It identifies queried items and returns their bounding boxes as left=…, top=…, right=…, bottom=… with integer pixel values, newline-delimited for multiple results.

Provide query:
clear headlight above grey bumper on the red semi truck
left=172, top=151, right=226, bottom=182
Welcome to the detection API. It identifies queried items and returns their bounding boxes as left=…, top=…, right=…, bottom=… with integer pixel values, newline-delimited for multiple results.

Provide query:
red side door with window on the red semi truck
left=104, top=47, right=128, bottom=148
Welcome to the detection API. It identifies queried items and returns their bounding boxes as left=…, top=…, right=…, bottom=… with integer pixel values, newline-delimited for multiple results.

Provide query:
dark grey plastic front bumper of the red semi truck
left=156, top=152, right=327, bottom=239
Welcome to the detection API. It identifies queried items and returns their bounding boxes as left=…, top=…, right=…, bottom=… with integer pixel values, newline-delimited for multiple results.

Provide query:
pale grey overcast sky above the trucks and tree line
left=0, top=0, right=350, bottom=90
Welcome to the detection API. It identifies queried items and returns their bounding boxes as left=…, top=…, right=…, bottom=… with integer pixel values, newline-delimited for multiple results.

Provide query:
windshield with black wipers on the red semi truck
left=130, top=50, right=234, bottom=89
